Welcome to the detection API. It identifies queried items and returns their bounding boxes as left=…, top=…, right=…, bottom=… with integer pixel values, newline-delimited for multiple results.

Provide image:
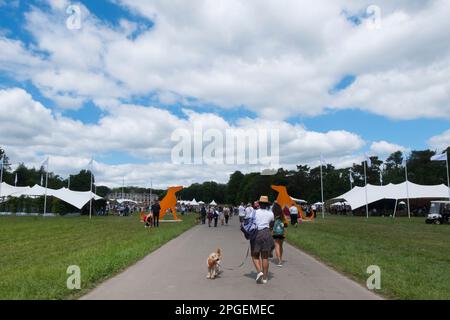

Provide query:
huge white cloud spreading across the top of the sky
left=0, top=0, right=450, bottom=119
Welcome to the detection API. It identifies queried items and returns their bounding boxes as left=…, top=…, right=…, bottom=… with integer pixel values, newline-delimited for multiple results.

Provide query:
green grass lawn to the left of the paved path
left=0, top=215, right=195, bottom=300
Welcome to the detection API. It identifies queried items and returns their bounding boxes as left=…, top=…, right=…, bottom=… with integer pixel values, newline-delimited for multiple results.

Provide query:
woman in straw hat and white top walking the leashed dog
left=250, top=196, right=274, bottom=283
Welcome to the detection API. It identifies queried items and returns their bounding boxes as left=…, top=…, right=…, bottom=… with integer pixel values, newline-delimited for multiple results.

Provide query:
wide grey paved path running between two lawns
left=82, top=217, right=380, bottom=300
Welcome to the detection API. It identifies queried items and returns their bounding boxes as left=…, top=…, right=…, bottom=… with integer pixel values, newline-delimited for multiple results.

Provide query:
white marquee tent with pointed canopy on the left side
left=0, top=182, right=102, bottom=209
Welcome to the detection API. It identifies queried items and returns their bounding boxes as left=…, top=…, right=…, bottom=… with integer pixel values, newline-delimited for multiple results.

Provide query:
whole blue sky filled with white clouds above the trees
left=0, top=0, right=450, bottom=188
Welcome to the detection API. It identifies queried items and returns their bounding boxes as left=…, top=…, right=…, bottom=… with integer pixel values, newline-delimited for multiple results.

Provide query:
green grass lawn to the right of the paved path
left=287, top=216, right=450, bottom=299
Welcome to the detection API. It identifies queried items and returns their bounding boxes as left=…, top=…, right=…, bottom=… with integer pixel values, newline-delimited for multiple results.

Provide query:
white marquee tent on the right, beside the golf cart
left=329, top=181, right=448, bottom=210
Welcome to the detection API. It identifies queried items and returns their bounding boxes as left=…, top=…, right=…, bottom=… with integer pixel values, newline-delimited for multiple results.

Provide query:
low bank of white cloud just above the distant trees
left=0, top=89, right=365, bottom=186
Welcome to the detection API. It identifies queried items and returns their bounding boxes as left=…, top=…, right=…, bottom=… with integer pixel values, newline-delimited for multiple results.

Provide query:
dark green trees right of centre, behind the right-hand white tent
left=179, top=148, right=450, bottom=205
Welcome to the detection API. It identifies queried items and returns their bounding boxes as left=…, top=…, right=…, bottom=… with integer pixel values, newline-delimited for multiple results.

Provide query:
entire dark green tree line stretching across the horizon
left=0, top=148, right=450, bottom=209
